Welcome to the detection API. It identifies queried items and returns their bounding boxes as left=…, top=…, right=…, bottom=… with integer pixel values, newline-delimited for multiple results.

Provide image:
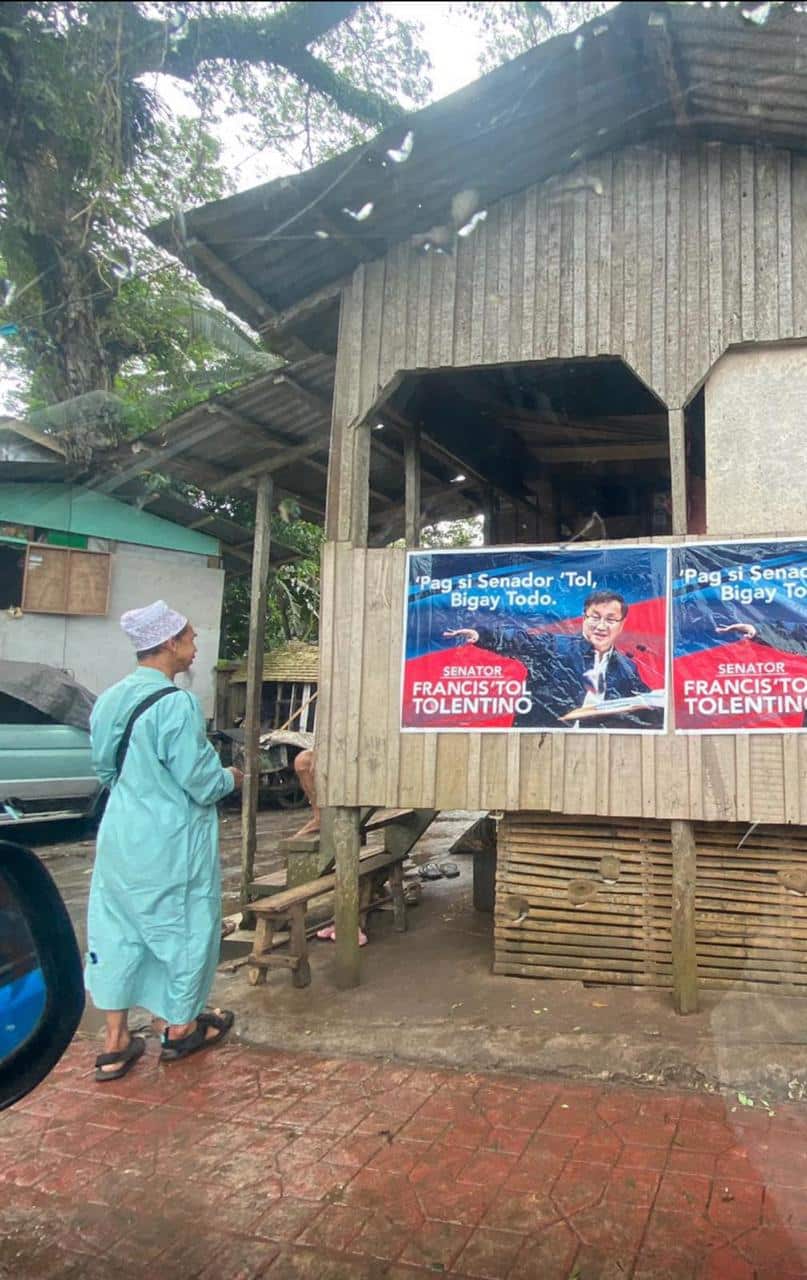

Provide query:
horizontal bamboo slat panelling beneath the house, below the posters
left=494, top=813, right=807, bottom=995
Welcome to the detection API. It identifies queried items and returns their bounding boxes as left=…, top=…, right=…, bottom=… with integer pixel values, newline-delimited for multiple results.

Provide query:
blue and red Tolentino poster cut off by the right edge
left=673, top=539, right=807, bottom=733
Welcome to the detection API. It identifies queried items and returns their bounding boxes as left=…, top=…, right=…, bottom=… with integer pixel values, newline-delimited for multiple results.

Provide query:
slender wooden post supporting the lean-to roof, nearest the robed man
left=241, top=475, right=273, bottom=928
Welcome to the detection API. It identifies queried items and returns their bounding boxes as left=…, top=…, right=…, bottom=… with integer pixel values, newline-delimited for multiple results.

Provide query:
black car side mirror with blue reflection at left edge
left=0, top=841, right=85, bottom=1110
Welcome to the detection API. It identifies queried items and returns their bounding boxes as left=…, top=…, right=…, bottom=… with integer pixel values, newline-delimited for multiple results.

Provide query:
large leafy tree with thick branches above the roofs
left=0, top=0, right=428, bottom=402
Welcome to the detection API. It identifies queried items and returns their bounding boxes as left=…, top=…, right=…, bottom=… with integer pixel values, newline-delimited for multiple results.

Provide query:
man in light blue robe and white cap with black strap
left=86, top=600, right=242, bottom=1080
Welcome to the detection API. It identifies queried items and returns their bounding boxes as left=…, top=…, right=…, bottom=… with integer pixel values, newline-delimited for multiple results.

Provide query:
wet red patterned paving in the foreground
left=0, top=1042, right=807, bottom=1280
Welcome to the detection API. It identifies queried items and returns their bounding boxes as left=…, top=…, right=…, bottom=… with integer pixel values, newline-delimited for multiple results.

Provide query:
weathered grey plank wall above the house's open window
left=328, top=142, right=807, bottom=543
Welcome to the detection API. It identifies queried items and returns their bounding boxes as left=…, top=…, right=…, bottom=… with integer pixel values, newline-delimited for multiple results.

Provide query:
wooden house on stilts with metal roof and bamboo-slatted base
left=158, top=3, right=807, bottom=1011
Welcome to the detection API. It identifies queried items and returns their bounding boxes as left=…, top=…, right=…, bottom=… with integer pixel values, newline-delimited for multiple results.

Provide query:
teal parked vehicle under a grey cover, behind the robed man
left=0, top=662, right=102, bottom=827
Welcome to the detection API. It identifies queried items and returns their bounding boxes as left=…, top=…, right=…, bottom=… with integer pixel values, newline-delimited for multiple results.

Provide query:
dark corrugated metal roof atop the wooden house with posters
left=154, top=3, right=807, bottom=326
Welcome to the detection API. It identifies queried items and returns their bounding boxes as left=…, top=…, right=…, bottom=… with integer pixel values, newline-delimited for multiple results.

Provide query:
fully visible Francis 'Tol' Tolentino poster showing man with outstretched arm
left=401, top=547, right=669, bottom=733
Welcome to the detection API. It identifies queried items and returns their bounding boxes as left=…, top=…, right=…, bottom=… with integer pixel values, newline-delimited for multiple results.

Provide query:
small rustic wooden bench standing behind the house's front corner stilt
left=247, top=850, right=406, bottom=987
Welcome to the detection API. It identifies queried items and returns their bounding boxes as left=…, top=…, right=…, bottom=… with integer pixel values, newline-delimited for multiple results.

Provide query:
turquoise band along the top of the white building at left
left=0, top=484, right=219, bottom=556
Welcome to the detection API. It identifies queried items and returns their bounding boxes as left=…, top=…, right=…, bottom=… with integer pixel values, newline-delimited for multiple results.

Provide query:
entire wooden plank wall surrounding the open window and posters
left=319, top=143, right=807, bottom=823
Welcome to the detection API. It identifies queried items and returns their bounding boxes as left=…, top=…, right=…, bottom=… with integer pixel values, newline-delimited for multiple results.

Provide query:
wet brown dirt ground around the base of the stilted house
left=26, top=810, right=807, bottom=1100
